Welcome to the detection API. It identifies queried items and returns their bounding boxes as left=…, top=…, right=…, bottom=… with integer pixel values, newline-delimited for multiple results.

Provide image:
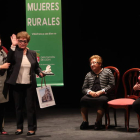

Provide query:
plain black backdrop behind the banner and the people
left=0, top=0, right=140, bottom=107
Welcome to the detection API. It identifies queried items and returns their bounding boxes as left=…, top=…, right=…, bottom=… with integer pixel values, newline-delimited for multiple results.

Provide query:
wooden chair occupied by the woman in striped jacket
left=105, top=66, right=120, bottom=129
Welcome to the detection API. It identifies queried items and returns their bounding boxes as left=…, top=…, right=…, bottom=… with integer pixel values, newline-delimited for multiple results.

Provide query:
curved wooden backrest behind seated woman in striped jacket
left=104, top=66, right=120, bottom=99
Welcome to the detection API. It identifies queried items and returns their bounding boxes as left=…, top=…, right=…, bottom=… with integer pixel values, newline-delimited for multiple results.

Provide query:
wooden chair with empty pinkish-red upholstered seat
left=106, top=68, right=140, bottom=131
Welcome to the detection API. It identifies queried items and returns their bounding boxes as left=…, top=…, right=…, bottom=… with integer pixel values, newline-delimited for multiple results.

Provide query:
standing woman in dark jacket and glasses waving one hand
left=7, top=31, right=44, bottom=136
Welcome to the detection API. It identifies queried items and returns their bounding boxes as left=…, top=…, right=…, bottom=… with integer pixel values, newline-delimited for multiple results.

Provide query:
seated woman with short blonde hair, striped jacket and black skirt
left=80, top=55, right=115, bottom=130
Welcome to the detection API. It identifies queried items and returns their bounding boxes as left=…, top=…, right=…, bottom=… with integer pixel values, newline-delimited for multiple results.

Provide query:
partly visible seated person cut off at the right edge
left=132, top=82, right=140, bottom=116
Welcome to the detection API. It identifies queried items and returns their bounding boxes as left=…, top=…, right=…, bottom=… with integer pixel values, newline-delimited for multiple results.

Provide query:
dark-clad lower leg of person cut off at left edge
left=0, top=103, right=6, bottom=130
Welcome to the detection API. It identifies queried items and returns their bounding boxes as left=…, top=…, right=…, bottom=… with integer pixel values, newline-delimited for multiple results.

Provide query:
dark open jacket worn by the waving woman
left=6, top=47, right=42, bottom=87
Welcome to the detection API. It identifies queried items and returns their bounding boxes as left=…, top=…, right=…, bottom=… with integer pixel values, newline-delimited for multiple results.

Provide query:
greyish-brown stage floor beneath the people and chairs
left=0, top=107, right=140, bottom=140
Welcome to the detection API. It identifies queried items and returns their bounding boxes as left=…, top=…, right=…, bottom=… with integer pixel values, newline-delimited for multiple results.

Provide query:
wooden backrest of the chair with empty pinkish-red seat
left=122, top=68, right=140, bottom=99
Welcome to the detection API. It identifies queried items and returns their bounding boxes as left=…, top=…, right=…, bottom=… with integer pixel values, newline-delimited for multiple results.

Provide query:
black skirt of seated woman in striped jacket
left=80, top=94, right=108, bottom=109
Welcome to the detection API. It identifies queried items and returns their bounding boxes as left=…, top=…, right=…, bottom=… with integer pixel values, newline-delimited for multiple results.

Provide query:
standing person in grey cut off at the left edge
left=0, top=37, right=10, bottom=135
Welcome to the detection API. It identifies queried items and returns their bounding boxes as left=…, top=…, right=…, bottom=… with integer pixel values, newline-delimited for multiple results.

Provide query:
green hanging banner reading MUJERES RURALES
left=26, top=0, right=64, bottom=86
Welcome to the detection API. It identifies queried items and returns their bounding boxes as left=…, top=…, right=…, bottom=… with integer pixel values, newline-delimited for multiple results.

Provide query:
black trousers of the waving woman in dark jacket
left=12, top=84, right=37, bottom=131
